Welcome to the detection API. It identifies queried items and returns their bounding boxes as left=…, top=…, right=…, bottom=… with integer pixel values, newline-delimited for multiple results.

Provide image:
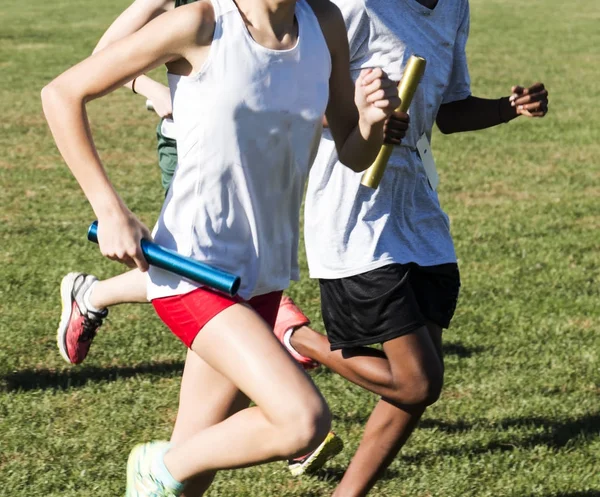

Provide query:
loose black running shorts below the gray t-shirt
left=319, top=263, right=460, bottom=350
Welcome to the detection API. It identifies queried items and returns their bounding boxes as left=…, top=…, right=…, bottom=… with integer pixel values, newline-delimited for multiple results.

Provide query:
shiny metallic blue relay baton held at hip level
left=88, top=221, right=240, bottom=295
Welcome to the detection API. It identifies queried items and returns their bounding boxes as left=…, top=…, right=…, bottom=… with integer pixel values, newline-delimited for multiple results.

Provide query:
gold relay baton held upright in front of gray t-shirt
left=361, top=55, right=427, bottom=188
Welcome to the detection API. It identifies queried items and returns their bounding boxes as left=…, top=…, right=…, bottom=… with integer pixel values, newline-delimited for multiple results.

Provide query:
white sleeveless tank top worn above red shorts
left=148, top=0, right=331, bottom=300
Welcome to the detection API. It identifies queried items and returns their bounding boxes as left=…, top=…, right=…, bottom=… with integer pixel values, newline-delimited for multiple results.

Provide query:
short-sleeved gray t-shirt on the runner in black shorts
left=304, top=0, right=471, bottom=279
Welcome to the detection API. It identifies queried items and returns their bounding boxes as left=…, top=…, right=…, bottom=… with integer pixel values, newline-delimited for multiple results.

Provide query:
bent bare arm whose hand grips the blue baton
left=42, top=2, right=215, bottom=271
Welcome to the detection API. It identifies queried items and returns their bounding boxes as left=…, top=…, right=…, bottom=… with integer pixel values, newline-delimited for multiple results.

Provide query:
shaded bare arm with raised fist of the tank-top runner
left=309, top=0, right=400, bottom=172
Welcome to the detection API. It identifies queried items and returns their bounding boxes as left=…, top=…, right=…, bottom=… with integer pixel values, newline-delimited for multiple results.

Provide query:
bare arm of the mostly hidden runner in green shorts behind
left=94, top=0, right=175, bottom=117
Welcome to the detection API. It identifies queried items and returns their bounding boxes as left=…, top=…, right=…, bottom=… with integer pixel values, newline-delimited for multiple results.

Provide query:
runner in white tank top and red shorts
left=42, top=0, right=399, bottom=496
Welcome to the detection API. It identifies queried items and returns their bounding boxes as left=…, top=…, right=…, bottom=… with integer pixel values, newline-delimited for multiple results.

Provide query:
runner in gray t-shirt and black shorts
left=275, top=0, right=548, bottom=497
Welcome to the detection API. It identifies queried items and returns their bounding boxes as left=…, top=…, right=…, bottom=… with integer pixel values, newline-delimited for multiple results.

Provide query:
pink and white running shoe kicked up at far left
left=56, top=273, right=108, bottom=364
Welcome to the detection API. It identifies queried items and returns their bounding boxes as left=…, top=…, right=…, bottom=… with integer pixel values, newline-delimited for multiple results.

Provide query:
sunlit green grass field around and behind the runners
left=0, top=0, right=600, bottom=497
